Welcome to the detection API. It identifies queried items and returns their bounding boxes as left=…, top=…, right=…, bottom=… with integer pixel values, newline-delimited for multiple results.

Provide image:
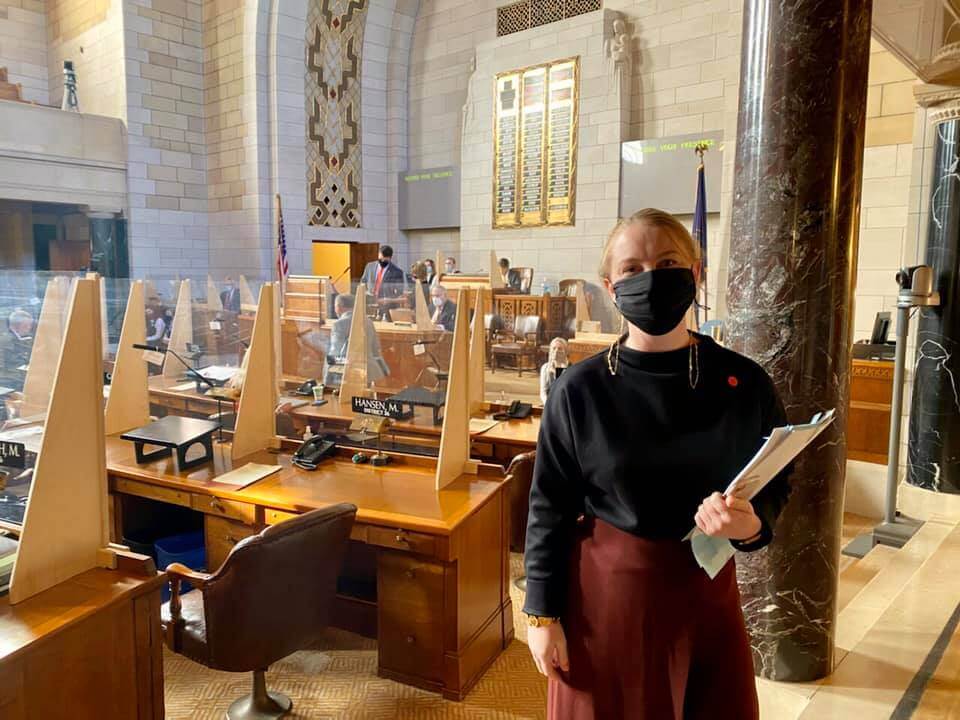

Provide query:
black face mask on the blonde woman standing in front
left=613, top=268, right=697, bottom=335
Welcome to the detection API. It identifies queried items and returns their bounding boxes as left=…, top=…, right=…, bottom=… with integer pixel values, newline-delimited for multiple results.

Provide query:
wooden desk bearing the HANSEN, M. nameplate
left=107, top=437, right=513, bottom=700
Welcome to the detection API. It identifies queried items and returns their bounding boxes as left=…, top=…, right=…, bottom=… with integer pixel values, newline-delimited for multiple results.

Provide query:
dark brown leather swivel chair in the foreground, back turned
left=160, top=503, right=357, bottom=720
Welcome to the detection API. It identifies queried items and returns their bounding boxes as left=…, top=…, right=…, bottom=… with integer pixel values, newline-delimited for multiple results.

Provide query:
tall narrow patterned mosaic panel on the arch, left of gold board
left=306, top=0, right=367, bottom=228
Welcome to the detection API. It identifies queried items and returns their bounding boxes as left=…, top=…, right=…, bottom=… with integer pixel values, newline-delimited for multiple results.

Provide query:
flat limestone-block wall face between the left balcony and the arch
left=124, top=0, right=209, bottom=279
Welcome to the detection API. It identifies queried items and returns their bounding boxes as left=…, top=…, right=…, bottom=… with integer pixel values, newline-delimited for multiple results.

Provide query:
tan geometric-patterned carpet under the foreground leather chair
left=163, top=555, right=547, bottom=720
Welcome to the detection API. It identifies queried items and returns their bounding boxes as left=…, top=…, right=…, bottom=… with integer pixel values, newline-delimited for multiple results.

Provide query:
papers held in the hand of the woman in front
left=687, top=410, right=834, bottom=579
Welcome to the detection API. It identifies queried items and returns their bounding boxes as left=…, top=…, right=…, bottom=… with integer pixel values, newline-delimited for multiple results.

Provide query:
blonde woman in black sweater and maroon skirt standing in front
left=524, top=210, right=789, bottom=720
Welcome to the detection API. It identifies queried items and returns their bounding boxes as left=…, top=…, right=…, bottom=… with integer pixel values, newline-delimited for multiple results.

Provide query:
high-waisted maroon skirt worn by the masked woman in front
left=547, top=519, right=760, bottom=720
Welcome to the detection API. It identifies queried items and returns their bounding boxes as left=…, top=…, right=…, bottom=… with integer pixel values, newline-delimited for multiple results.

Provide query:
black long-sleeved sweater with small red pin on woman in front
left=524, top=335, right=790, bottom=616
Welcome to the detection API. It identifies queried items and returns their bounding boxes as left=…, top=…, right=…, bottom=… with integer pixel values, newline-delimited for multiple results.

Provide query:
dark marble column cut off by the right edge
left=907, top=114, right=960, bottom=493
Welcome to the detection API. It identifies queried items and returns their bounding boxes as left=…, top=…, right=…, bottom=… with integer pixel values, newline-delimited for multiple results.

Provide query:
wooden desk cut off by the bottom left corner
left=0, top=568, right=166, bottom=720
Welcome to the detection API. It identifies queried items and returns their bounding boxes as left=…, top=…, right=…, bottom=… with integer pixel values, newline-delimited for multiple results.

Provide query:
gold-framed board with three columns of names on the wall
left=492, top=56, right=580, bottom=229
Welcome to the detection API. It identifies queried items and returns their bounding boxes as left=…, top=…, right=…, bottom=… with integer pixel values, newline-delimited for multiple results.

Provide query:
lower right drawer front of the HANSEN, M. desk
left=377, top=552, right=444, bottom=682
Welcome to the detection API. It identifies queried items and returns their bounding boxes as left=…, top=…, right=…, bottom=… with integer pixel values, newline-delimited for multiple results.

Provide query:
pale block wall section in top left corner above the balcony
left=0, top=0, right=50, bottom=105
